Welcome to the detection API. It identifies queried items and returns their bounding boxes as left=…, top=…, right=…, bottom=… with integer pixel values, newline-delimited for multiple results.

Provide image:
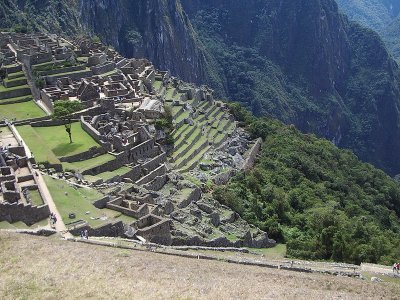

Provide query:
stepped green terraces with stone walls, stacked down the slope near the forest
left=154, top=81, right=236, bottom=172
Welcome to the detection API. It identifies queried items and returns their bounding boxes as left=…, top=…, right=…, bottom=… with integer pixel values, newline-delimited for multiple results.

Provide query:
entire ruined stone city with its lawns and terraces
left=0, top=32, right=275, bottom=248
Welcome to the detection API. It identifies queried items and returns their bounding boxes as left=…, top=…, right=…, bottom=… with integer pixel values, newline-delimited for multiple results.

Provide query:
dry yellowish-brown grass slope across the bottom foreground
left=0, top=232, right=400, bottom=299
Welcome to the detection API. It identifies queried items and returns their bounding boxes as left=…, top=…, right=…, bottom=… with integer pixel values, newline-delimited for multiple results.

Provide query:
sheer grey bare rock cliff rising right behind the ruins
left=79, top=0, right=207, bottom=82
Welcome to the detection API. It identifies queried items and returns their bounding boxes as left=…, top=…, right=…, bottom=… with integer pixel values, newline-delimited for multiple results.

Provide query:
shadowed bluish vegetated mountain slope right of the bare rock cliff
left=182, top=0, right=400, bottom=174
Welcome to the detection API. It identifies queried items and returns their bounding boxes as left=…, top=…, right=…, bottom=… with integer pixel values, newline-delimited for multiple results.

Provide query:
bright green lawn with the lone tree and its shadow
left=18, top=122, right=99, bottom=163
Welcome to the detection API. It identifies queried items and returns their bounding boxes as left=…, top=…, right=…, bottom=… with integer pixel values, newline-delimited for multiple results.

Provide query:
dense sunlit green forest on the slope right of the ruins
left=214, top=104, right=400, bottom=264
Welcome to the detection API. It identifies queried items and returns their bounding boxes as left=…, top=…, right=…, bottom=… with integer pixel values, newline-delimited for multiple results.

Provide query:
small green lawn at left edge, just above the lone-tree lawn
left=0, top=101, right=46, bottom=120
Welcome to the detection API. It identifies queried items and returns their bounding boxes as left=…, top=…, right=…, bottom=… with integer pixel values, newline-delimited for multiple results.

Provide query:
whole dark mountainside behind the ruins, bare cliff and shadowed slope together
left=0, top=0, right=400, bottom=175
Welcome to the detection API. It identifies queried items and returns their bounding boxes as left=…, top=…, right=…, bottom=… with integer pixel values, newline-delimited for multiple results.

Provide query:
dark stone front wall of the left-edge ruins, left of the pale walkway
left=0, top=203, right=50, bottom=226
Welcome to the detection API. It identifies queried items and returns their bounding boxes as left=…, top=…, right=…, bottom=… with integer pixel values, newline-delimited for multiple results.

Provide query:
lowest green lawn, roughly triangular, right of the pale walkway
left=44, top=176, right=135, bottom=226
